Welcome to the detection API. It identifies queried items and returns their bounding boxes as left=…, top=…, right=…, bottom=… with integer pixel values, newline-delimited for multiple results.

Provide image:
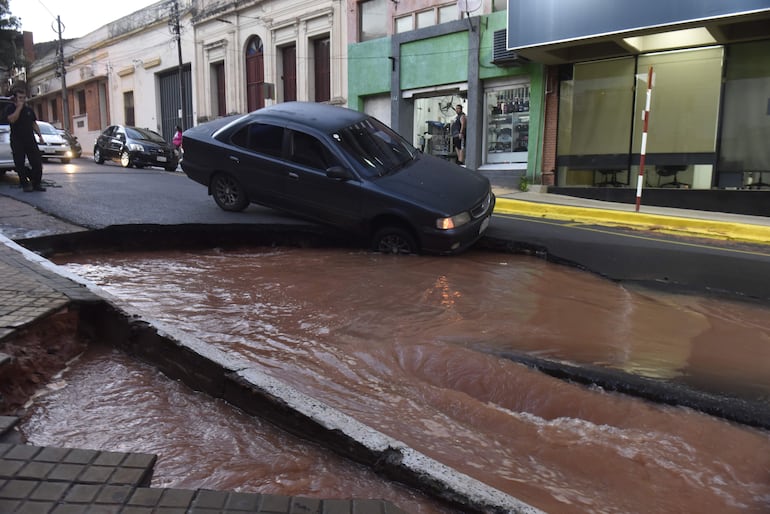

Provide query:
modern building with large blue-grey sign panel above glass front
left=506, top=0, right=770, bottom=194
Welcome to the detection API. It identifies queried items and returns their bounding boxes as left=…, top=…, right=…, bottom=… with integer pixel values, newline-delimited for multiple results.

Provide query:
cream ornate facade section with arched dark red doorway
left=192, top=0, right=347, bottom=122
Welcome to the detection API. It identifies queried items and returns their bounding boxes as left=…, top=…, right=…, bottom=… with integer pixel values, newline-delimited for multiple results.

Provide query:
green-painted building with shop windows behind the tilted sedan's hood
left=348, top=0, right=546, bottom=186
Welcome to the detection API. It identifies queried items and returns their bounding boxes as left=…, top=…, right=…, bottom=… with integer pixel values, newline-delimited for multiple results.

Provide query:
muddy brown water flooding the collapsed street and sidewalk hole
left=22, top=249, right=770, bottom=514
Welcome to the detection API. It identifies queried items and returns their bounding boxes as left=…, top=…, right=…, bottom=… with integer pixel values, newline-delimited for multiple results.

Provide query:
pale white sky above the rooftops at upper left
left=9, top=0, right=158, bottom=43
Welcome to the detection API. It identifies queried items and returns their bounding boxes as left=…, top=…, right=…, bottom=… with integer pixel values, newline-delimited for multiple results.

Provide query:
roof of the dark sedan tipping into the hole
left=249, top=102, right=369, bottom=134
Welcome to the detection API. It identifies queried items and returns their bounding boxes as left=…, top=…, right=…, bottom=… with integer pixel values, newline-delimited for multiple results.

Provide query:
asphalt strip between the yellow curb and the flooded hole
left=487, top=214, right=770, bottom=303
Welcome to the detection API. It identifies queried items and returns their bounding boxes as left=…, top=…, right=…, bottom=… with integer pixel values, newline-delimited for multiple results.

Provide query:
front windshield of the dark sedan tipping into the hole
left=332, top=118, right=417, bottom=176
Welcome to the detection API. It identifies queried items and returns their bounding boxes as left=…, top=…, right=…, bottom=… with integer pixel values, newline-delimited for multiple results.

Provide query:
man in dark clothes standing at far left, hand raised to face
left=5, top=84, right=45, bottom=192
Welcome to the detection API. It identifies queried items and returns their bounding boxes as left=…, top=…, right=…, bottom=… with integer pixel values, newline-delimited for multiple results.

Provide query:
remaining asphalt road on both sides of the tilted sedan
left=0, top=158, right=770, bottom=302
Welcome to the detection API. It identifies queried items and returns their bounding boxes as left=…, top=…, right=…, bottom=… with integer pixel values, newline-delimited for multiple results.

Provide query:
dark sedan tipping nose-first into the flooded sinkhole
left=182, top=102, right=495, bottom=253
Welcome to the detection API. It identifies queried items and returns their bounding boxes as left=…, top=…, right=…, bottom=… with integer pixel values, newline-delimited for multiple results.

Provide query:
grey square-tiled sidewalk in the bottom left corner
left=0, top=438, right=406, bottom=514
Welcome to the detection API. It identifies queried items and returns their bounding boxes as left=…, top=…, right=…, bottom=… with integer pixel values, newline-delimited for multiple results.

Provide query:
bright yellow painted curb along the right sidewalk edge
left=495, top=198, right=770, bottom=244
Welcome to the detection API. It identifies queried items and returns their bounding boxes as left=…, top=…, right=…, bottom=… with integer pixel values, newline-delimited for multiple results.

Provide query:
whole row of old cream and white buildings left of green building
left=27, top=0, right=347, bottom=153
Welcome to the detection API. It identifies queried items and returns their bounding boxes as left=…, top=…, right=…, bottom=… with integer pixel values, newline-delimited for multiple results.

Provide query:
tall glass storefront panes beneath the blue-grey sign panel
left=557, top=41, right=770, bottom=189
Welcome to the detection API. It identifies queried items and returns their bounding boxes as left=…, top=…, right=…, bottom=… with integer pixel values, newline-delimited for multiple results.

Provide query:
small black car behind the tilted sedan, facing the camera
left=94, top=125, right=179, bottom=171
